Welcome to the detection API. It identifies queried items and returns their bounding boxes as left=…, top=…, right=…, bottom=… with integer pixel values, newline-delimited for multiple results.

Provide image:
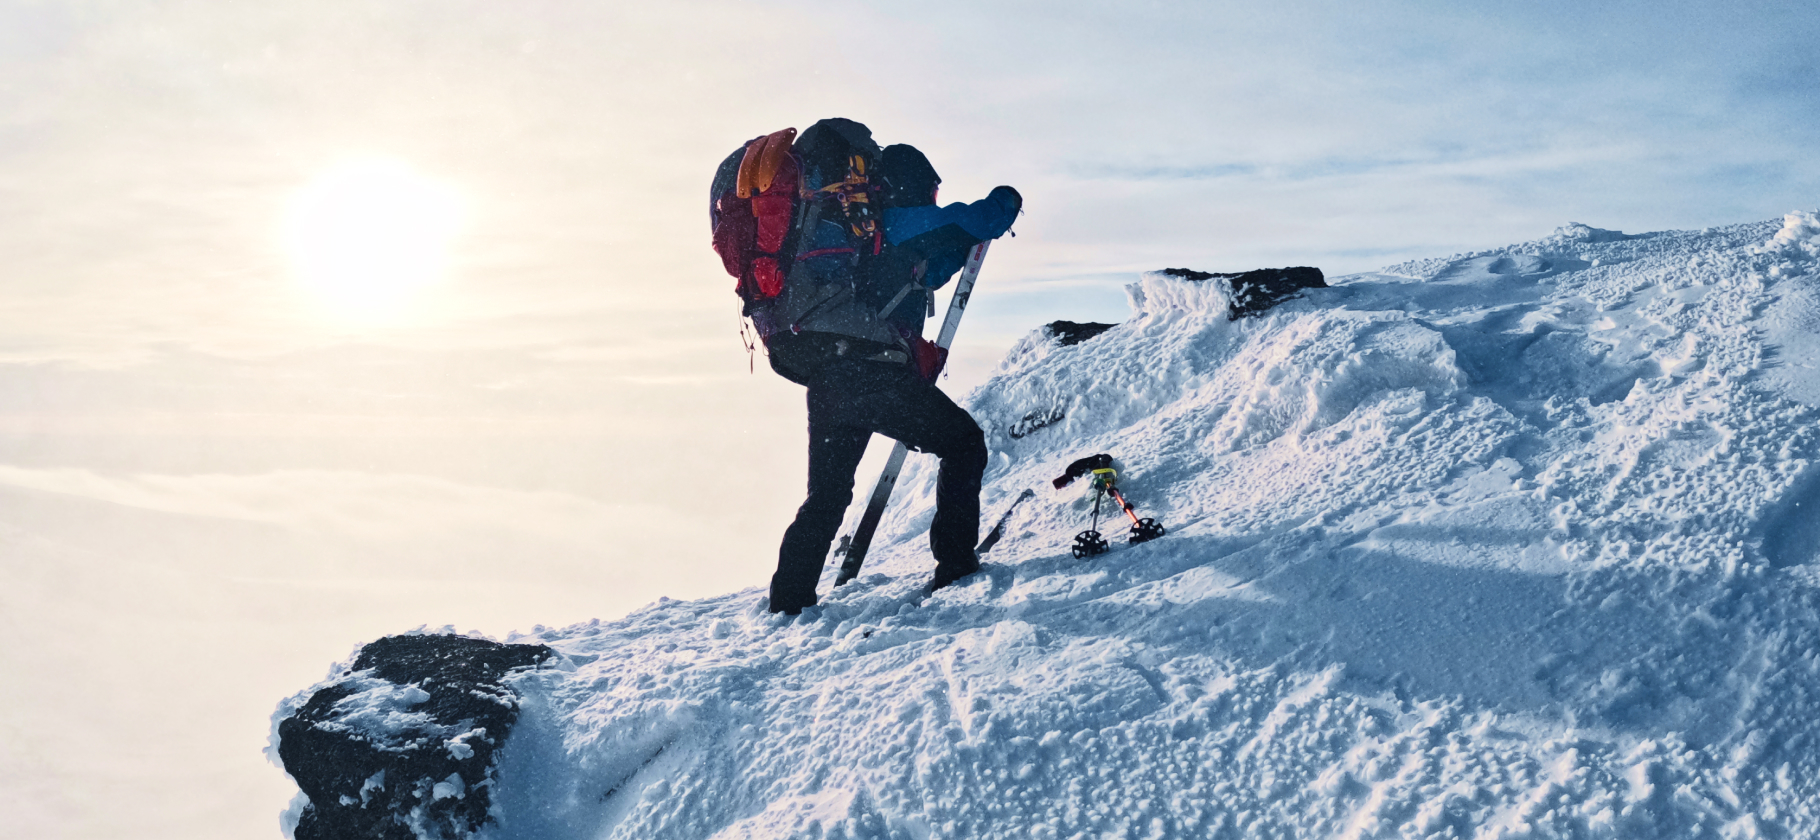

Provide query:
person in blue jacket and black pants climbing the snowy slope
left=753, top=132, right=1023, bottom=615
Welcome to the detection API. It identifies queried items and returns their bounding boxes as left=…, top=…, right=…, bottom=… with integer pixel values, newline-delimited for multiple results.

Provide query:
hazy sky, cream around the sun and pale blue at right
left=0, top=0, right=1820, bottom=838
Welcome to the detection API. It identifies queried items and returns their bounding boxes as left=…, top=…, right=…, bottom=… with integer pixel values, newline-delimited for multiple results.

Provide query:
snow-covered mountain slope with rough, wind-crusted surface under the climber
left=276, top=213, right=1820, bottom=840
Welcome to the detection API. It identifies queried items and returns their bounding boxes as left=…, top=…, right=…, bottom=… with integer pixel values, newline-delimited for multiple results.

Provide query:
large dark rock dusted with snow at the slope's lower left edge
left=278, top=636, right=555, bottom=840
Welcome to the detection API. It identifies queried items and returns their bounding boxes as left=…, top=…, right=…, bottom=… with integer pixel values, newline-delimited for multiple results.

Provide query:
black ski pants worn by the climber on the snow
left=770, top=362, right=986, bottom=613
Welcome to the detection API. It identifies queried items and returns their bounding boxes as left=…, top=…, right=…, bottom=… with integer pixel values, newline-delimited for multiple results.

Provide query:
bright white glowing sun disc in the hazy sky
left=284, top=158, right=466, bottom=320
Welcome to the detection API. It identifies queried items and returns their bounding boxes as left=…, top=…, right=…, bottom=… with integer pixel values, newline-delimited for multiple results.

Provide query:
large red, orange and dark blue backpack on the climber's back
left=708, top=118, right=901, bottom=350
